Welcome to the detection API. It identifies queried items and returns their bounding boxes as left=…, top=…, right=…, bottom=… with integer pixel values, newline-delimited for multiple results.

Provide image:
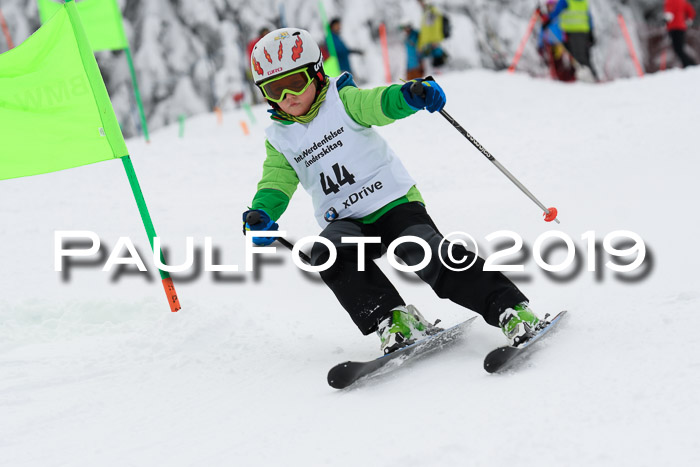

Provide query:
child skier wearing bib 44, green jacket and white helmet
left=243, top=28, right=545, bottom=353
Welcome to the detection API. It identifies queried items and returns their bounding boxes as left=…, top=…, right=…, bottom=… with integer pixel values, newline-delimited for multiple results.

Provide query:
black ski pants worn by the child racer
left=311, top=202, right=527, bottom=335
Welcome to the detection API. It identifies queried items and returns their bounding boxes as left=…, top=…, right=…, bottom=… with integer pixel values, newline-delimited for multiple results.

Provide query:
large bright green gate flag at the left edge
left=0, top=2, right=127, bottom=180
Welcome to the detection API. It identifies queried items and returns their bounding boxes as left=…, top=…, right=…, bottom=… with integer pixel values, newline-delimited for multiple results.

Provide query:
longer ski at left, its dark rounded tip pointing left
left=328, top=317, right=476, bottom=389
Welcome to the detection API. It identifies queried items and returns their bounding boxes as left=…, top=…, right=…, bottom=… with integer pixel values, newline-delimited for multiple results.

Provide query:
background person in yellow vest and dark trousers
left=543, top=0, right=598, bottom=81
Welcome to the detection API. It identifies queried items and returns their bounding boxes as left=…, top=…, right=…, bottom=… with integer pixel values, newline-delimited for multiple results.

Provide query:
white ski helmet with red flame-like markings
left=250, top=28, right=325, bottom=85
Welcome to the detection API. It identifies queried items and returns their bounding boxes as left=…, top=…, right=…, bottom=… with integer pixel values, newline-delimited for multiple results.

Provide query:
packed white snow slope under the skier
left=0, top=69, right=700, bottom=467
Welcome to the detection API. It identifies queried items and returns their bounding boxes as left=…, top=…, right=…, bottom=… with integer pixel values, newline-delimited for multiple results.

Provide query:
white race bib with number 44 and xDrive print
left=265, top=78, right=416, bottom=227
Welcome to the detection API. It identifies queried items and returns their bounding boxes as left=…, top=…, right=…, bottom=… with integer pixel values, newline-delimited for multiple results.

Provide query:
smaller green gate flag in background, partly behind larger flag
left=37, top=0, right=129, bottom=51
